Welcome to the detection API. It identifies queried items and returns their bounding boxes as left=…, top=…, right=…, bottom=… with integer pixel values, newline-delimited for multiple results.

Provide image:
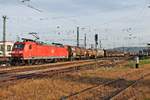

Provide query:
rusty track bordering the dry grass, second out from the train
left=0, top=58, right=125, bottom=87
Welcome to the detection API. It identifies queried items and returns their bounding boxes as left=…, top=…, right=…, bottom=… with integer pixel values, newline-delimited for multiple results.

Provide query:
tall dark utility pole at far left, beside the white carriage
left=2, top=16, right=7, bottom=58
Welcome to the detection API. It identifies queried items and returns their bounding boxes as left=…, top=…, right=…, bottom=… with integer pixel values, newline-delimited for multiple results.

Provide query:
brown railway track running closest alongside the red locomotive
left=0, top=58, right=126, bottom=75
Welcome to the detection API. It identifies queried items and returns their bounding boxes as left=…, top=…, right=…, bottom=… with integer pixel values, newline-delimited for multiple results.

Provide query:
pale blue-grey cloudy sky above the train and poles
left=0, top=0, right=150, bottom=48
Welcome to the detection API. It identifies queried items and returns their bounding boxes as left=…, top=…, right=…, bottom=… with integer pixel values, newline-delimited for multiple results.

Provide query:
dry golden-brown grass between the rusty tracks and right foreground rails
left=0, top=59, right=150, bottom=100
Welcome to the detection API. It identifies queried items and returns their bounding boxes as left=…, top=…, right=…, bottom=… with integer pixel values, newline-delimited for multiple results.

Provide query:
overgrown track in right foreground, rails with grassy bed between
left=61, top=66, right=150, bottom=100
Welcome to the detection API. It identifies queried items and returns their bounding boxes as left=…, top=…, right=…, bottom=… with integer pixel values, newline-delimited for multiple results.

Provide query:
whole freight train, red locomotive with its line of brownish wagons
left=11, top=39, right=124, bottom=65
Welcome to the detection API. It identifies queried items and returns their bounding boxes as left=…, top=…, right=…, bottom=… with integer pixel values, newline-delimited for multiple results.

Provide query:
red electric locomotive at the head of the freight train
left=11, top=39, right=69, bottom=65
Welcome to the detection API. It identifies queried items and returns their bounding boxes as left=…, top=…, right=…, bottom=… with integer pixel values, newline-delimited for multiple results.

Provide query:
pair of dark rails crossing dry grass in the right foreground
left=61, top=68, right=150, bottom=100
